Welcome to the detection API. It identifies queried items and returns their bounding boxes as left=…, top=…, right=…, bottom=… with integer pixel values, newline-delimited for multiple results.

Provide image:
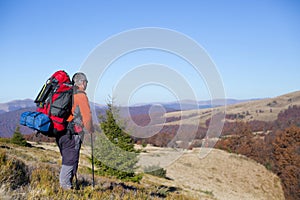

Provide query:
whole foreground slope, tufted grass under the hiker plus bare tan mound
left=0, top=136, right=284, bottom=200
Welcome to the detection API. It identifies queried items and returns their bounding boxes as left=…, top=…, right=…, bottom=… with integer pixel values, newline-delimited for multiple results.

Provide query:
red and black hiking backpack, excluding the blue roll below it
left=34, top=70, right=73, bottom=137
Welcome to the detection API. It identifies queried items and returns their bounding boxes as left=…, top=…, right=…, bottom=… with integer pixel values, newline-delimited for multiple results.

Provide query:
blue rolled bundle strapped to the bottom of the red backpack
left=20, top=111, right=51, bottom=133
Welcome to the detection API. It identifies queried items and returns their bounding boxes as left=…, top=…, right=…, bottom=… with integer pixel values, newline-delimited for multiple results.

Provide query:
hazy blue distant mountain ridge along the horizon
left=0, top=96, right=260, bottom=137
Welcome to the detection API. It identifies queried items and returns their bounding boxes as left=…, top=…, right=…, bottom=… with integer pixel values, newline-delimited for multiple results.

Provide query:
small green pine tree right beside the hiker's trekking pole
left=94, top=103, right=141, bottom=181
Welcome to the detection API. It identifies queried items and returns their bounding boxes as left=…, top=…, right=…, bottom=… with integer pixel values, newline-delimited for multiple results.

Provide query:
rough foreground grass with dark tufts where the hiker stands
left=0, top=142, right=203, bottom=199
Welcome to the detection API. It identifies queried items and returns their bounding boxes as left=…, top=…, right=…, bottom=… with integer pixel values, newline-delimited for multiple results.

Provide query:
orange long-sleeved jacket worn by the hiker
left=67, top=91, right=94, bottom=133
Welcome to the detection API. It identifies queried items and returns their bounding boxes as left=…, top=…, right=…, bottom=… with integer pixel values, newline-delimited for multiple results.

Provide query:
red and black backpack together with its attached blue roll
left=20, top=70, right=73, bottom=137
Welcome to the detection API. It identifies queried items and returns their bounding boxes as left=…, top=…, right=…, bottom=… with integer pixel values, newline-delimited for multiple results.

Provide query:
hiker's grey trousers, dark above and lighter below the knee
left=56, top=134, right=81, bottom=189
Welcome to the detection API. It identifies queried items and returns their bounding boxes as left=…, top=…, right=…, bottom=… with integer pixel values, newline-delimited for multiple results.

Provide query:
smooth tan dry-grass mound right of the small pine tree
left=138, top=146, right=284, bottom=200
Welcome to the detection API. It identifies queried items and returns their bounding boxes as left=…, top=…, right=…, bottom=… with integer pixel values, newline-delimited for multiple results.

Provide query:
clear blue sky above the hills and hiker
left=0, top=0, right=300, bottom=104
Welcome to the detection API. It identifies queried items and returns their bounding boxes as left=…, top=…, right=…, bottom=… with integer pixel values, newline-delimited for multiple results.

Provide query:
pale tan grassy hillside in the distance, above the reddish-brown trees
left=164, top=91, right=300, bottom=125
